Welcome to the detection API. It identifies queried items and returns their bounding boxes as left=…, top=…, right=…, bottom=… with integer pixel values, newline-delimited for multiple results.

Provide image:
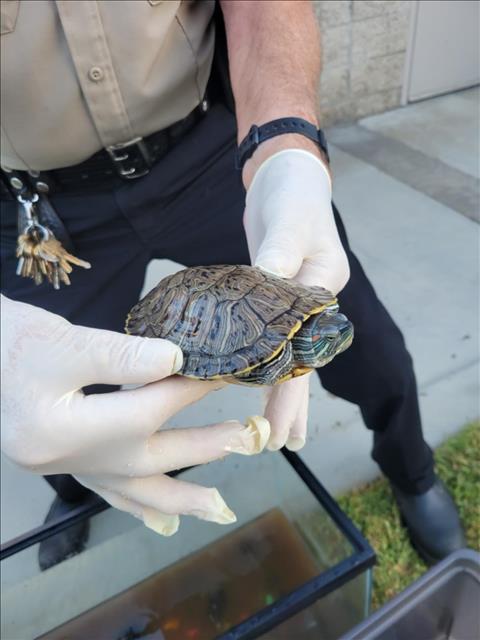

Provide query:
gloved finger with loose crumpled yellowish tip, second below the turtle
left=132, top=416, right=270, bottom=476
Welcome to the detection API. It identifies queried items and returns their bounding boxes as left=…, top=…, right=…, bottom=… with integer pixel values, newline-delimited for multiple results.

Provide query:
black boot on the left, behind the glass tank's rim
left=38, top=496, right=89, bottom=571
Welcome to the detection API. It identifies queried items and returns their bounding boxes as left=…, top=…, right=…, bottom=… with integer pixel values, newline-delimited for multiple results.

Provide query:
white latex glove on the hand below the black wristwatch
left=244, top=149, right=350, bottom=450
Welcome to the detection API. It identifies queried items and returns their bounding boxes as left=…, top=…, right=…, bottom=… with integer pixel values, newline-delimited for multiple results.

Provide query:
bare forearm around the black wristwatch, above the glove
left=221, top=0, right=324, bottom=187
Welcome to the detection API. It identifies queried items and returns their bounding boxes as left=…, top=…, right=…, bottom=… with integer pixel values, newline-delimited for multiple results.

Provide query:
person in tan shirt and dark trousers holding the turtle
left=1, top=0, right=465, bottom=568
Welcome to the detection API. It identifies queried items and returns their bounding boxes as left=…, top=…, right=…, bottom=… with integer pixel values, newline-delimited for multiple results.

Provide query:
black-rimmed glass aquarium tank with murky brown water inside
left=1, top=450, right=375, bottom=640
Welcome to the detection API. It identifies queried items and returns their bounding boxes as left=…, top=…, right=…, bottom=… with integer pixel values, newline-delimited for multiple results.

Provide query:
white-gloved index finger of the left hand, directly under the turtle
left=74, top=376, right=225, bottom=443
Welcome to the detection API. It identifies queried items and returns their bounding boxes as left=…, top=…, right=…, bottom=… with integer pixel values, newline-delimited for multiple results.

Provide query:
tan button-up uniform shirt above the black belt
left=0, top=0, right=214, bottom=170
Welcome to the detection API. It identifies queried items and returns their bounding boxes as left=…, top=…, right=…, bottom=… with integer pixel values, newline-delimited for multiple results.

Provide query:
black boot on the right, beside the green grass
left=391, top=478, right=467, bottom=565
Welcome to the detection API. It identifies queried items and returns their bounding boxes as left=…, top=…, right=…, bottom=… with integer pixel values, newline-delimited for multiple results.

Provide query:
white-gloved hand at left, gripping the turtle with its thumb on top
left=2, top=297, right=270, bottom=535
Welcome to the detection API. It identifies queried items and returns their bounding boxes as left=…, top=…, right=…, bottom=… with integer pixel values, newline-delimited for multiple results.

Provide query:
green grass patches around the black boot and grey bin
left=338, top=421, right=480, bottom=609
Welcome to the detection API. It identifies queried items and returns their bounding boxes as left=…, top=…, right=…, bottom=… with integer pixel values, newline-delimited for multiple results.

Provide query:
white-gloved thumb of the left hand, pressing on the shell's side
left=75, top=327, right=183, bottom=386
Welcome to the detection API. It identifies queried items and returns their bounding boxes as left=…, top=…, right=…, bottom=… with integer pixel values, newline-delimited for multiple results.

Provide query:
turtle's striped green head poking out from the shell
left=292, top=307, right=353, bottom=368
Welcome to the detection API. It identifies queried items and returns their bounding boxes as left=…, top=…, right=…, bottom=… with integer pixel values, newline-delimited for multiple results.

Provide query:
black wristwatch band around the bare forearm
left=235, top=118, right=330, bottom=169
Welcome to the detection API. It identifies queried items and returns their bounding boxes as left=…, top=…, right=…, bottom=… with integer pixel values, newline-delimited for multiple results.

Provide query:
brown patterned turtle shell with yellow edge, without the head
left=125, top=265, right=335, bottom=379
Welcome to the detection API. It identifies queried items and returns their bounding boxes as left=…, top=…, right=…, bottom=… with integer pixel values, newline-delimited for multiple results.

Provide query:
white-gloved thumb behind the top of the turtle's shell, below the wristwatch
left=254, top=225, right=303, bottom=278
